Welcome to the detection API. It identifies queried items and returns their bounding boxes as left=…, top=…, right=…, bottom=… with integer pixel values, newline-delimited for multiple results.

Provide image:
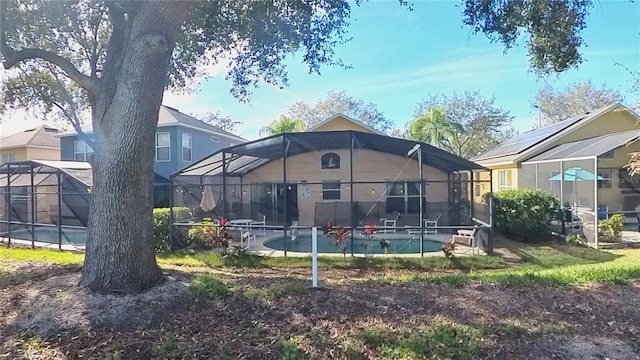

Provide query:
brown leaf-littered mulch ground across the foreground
left=0, top=261, right=640, bottom=360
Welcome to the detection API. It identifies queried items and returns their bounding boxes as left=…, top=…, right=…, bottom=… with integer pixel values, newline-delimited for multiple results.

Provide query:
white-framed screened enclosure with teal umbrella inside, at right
left=521, top=130, right=640, bottom=247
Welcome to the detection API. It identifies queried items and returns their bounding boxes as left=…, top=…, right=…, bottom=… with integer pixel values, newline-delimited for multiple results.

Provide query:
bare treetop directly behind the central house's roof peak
left=287, top=91, right=393, bottom=132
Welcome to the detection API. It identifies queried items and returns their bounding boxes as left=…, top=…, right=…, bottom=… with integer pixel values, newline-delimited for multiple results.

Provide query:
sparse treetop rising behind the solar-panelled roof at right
left=532, top=80, right=624, bottom=126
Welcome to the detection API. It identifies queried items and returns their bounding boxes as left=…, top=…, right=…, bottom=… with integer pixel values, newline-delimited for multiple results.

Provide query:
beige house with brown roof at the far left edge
left=0, top=125, right=60, bottom=163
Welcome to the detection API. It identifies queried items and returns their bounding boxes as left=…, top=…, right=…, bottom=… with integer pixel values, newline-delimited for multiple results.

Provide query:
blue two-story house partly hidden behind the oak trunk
left=59, top=105, right=247, bottom=207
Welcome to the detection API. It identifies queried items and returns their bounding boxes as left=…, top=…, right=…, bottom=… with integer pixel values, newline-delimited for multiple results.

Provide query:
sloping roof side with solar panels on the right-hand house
left=472, top=103, right=622, bottom=161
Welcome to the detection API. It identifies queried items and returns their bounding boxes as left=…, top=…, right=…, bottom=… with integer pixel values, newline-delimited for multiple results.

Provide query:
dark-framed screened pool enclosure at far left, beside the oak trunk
left=0, top=160, right=92, bottom=249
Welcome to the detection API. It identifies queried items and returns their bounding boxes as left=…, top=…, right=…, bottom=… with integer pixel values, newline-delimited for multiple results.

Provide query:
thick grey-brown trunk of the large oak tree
left=81, top=2, right=190, bottom=292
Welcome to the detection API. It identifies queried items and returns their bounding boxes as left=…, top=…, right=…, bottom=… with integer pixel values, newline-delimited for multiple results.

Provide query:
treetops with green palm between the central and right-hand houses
left=406, top=91, right=515, bottom=159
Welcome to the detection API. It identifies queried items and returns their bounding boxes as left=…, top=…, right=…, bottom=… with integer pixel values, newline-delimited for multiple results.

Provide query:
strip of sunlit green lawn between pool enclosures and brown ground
left=0, top=238, right=640, bottom=286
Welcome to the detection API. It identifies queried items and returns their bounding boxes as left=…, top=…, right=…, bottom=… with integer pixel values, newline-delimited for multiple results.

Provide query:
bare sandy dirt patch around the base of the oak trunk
left=0, top=267, right=191, bottom=337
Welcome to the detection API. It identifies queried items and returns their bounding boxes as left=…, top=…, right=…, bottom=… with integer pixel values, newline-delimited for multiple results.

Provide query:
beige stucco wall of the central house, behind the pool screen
left=243, top=149, right=449, bottom=225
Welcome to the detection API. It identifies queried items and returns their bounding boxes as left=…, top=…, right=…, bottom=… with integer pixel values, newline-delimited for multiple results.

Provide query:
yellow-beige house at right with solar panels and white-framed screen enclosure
left=475, top=104, right=640, bottom=247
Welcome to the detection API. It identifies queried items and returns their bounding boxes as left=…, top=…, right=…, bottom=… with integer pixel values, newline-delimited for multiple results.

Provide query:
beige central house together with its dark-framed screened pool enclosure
left=174, top=115, right=489, bottom=229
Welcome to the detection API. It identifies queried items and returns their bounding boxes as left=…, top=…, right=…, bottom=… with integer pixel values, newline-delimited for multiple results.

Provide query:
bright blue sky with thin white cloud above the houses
left=3, top=0, right=640, bottom=139
